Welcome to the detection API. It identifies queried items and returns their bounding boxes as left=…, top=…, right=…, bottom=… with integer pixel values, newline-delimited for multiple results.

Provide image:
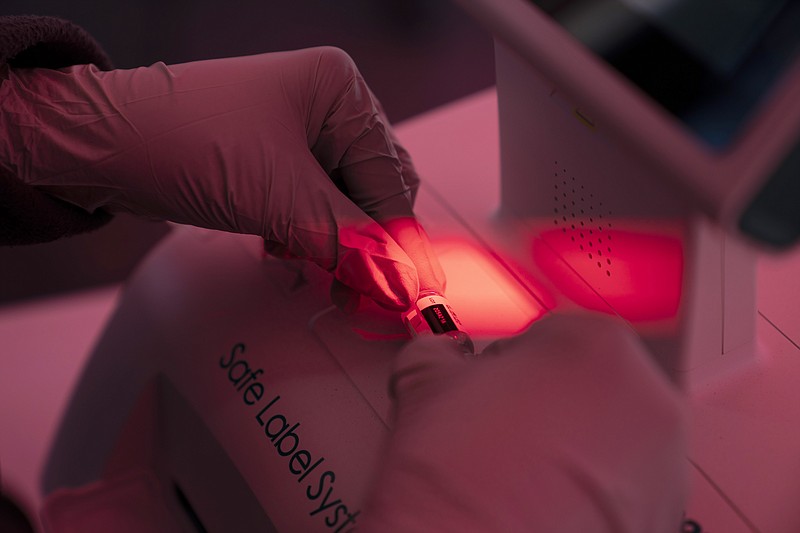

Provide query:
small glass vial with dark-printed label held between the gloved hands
left=403, top=291, right=475, bottom=354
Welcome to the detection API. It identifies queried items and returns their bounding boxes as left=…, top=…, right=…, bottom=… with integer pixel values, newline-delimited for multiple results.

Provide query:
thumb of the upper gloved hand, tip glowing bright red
left=258, top=149, right=419, bottom=310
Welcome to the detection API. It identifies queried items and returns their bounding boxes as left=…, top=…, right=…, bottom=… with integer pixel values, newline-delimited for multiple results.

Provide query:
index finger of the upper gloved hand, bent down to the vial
left=308, top=49, right=445, bottom=292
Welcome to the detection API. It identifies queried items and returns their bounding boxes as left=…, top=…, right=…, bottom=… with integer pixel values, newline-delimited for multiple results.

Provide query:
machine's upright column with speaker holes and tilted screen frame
left=459, top=0, right=800, bottom=386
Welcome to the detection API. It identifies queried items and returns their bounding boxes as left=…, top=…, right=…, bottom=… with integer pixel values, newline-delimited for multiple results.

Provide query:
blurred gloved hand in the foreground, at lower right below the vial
left=358, top=317, right=686, bottom=533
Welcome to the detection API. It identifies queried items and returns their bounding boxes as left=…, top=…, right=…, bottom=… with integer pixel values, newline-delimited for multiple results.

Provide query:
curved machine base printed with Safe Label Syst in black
left=44, top=230, right=396, bottom=531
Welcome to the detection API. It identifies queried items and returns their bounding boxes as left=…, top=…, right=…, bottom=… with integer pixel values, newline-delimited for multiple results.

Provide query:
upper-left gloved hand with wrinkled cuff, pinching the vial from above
left=0, top=47, right=444, bottom=310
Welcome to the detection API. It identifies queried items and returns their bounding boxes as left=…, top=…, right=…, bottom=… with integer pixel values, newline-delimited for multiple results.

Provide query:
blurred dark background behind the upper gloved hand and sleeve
left=0, top=0, right=494, bottom=305
